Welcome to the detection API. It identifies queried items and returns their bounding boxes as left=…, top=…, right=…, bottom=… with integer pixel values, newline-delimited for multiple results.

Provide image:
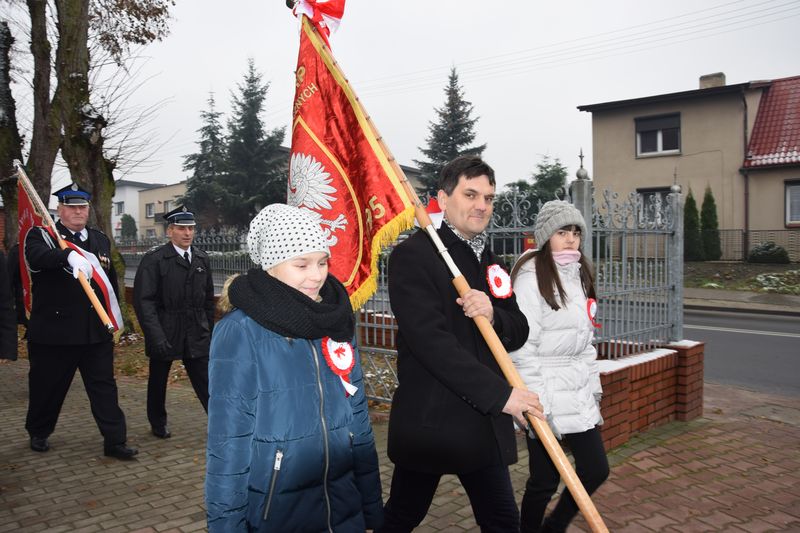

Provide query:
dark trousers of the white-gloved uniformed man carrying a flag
left=25, top=340, right=127, bottom=445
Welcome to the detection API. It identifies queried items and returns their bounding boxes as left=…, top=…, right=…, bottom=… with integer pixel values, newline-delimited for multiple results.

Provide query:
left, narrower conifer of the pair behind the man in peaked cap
left=180, top=93, right=232, bottom=228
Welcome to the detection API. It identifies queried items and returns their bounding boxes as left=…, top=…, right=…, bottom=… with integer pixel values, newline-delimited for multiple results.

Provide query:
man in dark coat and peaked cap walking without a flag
left=133, top=206, right=214, bottom=439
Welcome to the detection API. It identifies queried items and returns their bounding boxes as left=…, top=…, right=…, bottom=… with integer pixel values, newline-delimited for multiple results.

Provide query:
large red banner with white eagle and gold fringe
left=287, top=16, right=414, bottom=309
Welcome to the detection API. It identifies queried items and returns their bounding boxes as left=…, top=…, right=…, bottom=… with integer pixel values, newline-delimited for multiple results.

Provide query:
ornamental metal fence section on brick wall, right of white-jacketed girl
left=590, top=188, right=683, bottom=359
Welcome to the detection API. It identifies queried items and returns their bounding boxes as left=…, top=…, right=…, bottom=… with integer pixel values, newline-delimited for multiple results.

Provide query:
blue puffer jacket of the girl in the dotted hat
left=205, top=310, right=383, bottom=533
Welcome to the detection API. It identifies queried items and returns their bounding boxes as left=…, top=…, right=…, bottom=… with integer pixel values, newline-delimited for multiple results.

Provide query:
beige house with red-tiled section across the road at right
left=578, top=73, right=800, bottom=261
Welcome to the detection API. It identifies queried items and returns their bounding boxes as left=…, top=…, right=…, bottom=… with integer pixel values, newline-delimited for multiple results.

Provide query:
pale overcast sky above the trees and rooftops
left=103, top=0, right=800, bottom=191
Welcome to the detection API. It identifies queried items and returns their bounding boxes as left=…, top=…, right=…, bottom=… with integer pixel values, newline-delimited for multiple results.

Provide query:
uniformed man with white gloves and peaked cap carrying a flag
left=24, top=183, right=138, bottom=459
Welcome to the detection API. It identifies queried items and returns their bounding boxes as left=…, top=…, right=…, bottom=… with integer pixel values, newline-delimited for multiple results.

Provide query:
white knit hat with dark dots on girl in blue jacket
left=247, top=204, right=330, bottom=270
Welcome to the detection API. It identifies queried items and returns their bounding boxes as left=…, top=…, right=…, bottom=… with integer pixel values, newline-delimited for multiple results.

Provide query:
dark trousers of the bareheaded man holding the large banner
left=376, top=465, right=519, bottom=533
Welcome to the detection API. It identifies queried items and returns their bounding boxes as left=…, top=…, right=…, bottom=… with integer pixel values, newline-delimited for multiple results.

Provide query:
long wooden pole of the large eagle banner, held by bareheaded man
left=287, top=12, right=608, bottom=533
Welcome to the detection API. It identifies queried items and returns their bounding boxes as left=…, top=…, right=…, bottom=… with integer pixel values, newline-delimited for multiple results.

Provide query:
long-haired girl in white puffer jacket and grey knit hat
left=510, top=200, right=608, bottom=533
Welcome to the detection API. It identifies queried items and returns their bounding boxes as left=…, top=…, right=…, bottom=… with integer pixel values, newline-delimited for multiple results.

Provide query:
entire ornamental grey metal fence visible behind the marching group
left=118, top=180, right=683, bottom=402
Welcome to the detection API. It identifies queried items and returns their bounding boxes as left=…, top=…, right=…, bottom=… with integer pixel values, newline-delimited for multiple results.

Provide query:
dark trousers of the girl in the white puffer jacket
left=521, top=427, right=608, bottom=533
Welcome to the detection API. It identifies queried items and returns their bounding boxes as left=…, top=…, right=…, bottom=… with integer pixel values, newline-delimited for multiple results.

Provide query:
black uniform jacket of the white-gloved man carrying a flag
left=25, top=221, right=119, bottom=345
